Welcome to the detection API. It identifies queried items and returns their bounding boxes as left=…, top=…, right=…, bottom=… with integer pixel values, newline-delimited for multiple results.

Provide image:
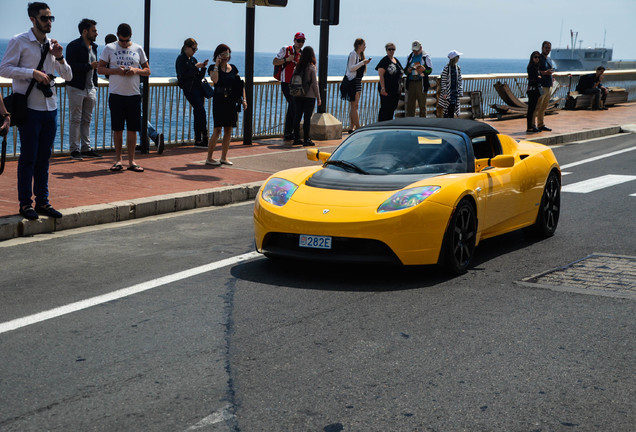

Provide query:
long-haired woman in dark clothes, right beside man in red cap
left=290, top=46, right=322, bottom=147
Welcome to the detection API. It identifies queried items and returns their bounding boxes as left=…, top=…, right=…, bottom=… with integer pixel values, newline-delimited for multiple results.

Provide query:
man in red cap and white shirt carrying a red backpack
left=272, top=32, right=305, bottom=141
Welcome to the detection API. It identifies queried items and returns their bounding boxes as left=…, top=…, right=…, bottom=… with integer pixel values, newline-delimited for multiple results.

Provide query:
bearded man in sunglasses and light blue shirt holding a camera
left=0, top=2, right=73, bottom=220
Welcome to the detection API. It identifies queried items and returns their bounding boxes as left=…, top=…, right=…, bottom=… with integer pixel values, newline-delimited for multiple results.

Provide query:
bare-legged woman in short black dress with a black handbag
left=205, top=44, right=247, bottom=166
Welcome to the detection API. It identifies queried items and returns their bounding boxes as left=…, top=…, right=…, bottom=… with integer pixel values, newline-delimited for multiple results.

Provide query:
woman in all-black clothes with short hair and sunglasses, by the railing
left=375, top=42, right=404, bottom=121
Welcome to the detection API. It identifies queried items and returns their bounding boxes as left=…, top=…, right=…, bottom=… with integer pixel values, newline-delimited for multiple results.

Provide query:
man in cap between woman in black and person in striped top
left=406, top=41, right=433, bottom=117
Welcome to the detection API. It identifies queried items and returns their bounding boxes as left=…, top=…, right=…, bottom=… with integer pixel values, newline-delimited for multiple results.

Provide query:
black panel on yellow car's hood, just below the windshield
left=305, top=168, right=438, bottom=191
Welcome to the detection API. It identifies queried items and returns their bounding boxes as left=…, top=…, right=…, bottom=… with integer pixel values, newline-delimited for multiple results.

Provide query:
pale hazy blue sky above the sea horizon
left=0, top=0, right=636, bottom=60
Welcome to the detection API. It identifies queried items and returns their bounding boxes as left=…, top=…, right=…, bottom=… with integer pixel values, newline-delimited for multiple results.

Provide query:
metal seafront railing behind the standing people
left=0, top=70, right=636, bottom=157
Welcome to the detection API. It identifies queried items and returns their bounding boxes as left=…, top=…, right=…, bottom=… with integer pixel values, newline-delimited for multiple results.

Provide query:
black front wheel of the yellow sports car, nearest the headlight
left=443, top=199, right=477, bottom=274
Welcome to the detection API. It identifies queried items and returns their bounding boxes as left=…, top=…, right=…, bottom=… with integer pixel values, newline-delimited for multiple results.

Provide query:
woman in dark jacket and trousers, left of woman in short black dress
left=175, top=38, right=211, bottom=148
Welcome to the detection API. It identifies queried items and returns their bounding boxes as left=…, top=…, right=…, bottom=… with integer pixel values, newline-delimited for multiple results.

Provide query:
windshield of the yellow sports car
left=326, top=129, right=467, bottom=175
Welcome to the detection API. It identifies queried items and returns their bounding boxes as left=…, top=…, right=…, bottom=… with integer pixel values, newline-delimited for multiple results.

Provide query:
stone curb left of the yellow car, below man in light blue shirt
left=0, top=182, right=263, bottom=241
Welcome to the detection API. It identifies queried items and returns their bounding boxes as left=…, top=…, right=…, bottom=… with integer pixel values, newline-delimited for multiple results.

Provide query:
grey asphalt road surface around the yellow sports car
left=0, top=135, right=636, bottom=432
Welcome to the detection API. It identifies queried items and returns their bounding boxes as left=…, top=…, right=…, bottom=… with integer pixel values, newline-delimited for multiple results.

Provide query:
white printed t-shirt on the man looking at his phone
left=100, top=42, right=148, bottom=96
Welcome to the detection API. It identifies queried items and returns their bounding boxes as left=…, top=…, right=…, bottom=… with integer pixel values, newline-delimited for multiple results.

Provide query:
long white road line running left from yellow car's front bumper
left=0, top=252, right=262, bottom=334
